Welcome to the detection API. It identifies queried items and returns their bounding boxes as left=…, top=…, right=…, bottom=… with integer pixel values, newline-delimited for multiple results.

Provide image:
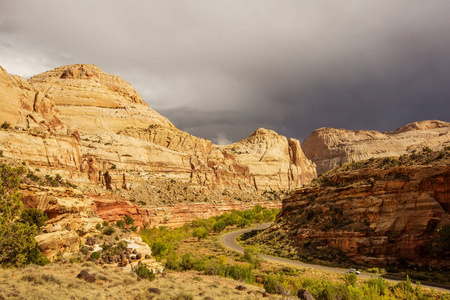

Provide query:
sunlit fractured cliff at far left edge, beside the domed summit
left=0, top=68, right=82, bottom=173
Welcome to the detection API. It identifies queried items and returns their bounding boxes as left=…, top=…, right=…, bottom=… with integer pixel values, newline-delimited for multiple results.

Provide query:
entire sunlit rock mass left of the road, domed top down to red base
left=0, top=65, right=315, bottom=260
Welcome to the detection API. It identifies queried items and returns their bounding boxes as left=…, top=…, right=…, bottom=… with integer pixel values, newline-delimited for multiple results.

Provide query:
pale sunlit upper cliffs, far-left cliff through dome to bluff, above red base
left=0, top=64, right=316, bottom=192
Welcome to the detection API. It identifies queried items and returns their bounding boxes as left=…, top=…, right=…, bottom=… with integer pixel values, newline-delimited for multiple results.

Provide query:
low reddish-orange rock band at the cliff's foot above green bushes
left=93, top=198, right=281, bottom=228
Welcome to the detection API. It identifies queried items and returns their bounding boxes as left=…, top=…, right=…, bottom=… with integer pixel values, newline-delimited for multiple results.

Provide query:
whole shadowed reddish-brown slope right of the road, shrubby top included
left=246, top=148, right=450, bottom=269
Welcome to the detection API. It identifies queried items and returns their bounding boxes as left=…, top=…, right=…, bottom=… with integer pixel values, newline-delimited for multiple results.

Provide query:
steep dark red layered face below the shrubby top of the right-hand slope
left=279, top=166, right=450, bottom=268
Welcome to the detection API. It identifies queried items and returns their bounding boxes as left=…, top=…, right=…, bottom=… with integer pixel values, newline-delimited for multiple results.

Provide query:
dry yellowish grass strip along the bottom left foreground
left=0, top=263, right=288, bottom=300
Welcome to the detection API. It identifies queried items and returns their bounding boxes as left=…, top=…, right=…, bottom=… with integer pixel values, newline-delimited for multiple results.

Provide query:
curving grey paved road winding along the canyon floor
left=222, top=223, right=450, bottom=293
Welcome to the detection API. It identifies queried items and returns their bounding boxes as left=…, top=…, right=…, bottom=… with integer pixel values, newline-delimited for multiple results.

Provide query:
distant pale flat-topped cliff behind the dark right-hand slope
left=302, top=120, right=450, bottom=174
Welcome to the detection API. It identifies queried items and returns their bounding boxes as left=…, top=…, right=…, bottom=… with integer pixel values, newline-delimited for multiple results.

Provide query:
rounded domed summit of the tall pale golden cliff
left=29, top=64, right=173, bottom=134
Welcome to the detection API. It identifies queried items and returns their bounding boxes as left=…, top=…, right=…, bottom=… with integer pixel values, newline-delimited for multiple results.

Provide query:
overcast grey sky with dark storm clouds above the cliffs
left=0, top=0, right=450, bottom=143
